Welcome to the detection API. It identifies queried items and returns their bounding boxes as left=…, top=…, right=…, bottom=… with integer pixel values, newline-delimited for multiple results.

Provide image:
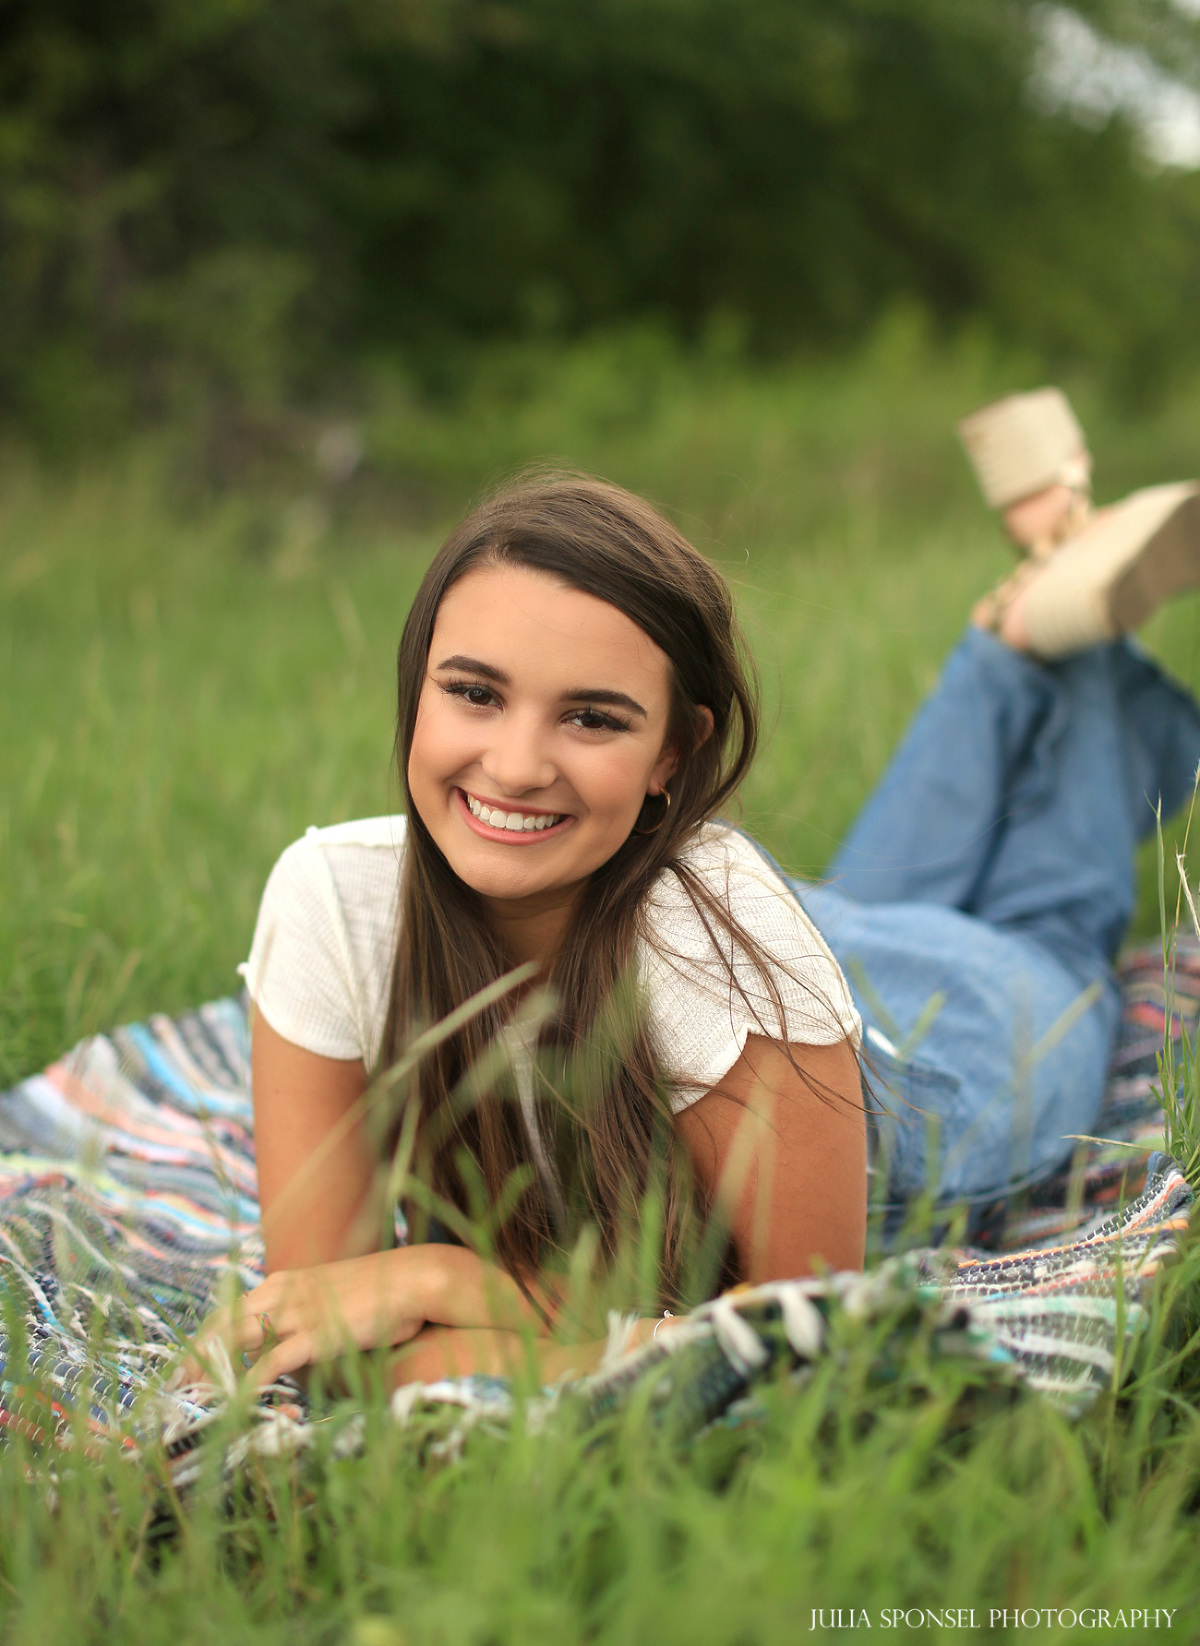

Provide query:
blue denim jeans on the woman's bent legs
left=790, top=629, right=1200, bottom=1202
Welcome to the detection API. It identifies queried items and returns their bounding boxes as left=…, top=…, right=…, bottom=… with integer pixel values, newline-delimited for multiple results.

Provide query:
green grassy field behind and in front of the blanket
left=0, top=327, right=1200, bottom=1646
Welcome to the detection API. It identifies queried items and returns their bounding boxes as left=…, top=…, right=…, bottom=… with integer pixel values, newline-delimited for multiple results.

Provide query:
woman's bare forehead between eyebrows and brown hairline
left=430, top=565, right=670, bottom=708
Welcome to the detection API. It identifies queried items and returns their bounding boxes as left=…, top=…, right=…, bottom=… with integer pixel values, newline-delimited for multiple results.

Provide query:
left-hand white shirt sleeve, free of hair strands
left=239, top=833, right=370, bottom=1060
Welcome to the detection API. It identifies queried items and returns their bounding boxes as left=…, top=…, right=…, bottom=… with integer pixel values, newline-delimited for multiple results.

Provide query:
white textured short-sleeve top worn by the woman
left=239, top=816, right=863, bottom=1111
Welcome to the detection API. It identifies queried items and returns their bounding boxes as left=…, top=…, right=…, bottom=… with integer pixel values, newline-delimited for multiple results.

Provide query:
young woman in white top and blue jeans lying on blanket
left=214, top=479, right=1200, bottom=1379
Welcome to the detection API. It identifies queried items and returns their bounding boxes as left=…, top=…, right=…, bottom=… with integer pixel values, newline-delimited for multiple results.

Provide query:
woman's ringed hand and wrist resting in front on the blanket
left=183, top=1246, right=440, bottom=1384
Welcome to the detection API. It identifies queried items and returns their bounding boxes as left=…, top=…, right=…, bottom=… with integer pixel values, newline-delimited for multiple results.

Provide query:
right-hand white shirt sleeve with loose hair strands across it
left=642, top=846, right=863, bottom=1113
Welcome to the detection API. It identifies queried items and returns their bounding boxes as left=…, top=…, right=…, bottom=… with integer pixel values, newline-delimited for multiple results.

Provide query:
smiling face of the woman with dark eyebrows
left=408, top=565, right=675, bottom=928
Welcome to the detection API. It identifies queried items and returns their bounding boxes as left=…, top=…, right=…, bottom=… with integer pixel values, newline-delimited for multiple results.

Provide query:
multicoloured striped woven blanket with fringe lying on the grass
left=0, top=946, right=1200, bottom=1483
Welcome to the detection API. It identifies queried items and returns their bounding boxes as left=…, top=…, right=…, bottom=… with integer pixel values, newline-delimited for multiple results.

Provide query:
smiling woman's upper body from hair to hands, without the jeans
left=217, top=479, right=866, bottom=1376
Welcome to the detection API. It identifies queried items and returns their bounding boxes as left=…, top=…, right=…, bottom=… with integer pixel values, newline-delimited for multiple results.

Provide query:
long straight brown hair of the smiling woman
left=380, top=477, right=796, bottom=1294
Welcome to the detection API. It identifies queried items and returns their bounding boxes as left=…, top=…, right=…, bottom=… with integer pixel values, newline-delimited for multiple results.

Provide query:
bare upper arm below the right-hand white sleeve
left=675, top=1035, right=866, bottom=1282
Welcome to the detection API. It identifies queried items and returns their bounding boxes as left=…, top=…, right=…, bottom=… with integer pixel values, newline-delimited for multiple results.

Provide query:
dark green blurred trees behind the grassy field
left=0, top=0, right=1200, bottom=438
